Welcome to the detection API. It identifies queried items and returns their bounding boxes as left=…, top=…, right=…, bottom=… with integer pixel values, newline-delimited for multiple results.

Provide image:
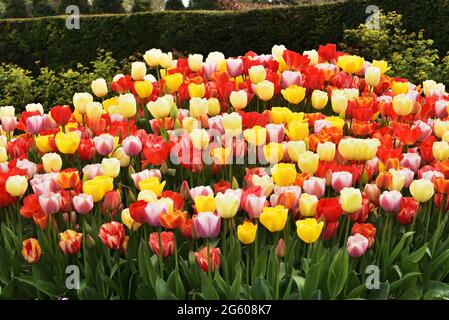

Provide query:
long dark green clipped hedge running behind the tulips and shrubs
left=0, top=0, right=449, bottom=70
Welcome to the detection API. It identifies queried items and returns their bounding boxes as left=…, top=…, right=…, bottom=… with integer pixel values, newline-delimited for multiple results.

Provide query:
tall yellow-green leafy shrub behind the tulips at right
left=342, top=12, right=448, bottom=83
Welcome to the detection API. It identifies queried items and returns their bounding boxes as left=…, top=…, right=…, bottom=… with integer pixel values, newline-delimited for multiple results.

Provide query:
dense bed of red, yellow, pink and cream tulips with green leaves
left=0, top=44, right=449, bottom=299
